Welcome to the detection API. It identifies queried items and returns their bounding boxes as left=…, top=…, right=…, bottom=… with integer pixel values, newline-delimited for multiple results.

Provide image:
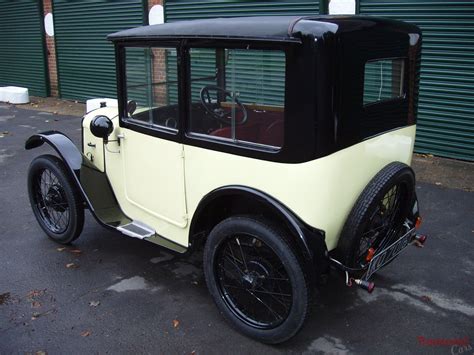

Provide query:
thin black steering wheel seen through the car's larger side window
left=200, top=85, right=247, bottom=126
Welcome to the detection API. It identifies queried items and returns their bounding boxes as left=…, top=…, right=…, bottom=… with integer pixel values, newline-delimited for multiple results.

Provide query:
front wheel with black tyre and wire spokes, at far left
left=28, top=155, right=84, bottom=244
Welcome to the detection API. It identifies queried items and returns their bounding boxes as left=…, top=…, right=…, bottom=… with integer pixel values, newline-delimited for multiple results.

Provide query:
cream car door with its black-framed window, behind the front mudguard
left=111, top=47, right=187, bottom=232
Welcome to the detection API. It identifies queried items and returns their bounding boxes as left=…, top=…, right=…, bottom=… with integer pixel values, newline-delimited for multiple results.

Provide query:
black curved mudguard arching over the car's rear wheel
left=190, top=185, right=329, bottom=281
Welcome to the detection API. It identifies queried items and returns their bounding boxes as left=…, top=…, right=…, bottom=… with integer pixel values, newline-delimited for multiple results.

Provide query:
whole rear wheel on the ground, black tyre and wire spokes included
left=204, top=217, right=310, bottom=344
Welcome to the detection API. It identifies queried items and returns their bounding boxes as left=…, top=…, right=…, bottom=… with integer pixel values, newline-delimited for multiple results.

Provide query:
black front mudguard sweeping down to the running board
left=25, top=131, right=131, bottom=229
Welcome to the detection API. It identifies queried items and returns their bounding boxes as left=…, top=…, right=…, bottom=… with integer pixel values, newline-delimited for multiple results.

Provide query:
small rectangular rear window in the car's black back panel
left=364, top=58, right=405, bottom=105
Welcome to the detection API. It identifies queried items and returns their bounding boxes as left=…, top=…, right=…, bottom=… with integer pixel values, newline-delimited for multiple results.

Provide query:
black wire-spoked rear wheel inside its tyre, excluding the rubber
left=216, top=234, right=293, bottom=329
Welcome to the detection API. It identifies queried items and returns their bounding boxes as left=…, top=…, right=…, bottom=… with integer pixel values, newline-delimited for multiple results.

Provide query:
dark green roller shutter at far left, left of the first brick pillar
left=0, top=0, right=48, bottom=96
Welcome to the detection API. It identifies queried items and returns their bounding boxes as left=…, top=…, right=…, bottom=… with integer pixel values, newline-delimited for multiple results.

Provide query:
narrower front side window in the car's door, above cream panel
left=125, top=47, right=179, bottom=131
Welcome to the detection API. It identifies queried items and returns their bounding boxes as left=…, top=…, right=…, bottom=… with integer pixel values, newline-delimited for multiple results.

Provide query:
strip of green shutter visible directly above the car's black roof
left=165, top=0, right=319, bottom=22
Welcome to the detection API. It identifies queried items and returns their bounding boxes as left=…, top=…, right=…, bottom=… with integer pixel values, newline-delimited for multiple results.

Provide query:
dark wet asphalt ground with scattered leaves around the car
left=0, top=105, right=474, bottom=354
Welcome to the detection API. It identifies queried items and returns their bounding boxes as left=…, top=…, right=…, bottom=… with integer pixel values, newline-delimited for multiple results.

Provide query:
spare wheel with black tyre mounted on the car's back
left=337, top=162, right=415, bottom=268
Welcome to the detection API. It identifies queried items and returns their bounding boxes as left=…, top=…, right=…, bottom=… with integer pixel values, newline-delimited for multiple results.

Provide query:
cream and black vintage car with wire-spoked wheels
left=26, top=16, right=426, bottom=343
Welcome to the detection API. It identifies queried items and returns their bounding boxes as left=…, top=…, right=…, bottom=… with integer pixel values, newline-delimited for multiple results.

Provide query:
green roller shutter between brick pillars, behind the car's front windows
left=54, top=0, right=144, bottom=101
